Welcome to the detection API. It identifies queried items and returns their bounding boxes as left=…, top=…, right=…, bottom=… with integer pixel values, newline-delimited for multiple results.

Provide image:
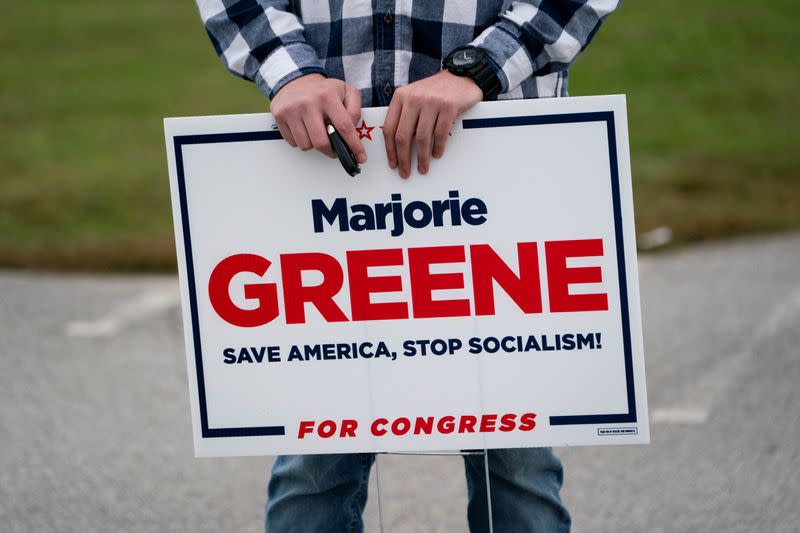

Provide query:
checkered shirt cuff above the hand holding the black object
left=255, top=42, right=328, bottom=100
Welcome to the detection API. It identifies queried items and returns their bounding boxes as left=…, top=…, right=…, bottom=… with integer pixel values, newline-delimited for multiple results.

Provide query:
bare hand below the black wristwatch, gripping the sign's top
left=383, top=70, right=483, bottom=178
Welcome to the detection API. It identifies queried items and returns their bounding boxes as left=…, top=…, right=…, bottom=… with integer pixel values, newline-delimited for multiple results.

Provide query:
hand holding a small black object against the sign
left=270, top=74, right=367, bottom=163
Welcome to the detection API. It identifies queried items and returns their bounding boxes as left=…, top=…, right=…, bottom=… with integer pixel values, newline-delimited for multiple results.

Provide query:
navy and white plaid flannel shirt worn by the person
left=196, top=0, right=621, bottom=107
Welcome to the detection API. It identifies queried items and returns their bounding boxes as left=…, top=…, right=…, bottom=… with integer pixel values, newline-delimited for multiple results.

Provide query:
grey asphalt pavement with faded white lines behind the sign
left=0, top=233, right=800, bottom=533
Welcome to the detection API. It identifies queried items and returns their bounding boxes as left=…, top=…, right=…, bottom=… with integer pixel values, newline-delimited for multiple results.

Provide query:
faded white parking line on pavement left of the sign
left=64, top=283, right=180, bottom=338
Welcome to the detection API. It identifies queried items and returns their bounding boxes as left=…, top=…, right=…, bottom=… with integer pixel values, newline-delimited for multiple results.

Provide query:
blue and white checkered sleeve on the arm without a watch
left=196, top=0, right=327, bottom=98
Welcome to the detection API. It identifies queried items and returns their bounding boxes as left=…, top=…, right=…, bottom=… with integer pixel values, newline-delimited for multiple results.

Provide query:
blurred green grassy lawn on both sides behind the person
left=0, top=0, right=800, bottom=270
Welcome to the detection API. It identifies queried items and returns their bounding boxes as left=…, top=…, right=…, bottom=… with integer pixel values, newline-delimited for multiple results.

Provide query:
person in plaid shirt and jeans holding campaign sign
left=196, top=0, right=619, bottom=533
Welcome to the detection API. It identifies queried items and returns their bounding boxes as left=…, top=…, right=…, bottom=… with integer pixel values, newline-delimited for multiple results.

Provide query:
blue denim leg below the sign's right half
left=464, top=448, right=572, bottom=533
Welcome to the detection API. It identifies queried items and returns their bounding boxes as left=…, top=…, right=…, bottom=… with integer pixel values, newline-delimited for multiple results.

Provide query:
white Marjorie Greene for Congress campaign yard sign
left=165, top=96, right=649, bottom=456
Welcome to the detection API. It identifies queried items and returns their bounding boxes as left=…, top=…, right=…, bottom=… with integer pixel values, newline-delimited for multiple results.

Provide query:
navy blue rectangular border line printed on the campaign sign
left=173, top=111, right=637, bottom=438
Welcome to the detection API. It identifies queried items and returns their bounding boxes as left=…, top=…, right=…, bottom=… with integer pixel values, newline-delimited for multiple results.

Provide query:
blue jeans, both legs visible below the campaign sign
left=266, top=448, right=571, bottom=533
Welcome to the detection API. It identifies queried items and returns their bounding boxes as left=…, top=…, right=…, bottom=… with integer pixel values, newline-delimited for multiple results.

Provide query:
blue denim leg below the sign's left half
left=265, top=453, right=375, bottom=533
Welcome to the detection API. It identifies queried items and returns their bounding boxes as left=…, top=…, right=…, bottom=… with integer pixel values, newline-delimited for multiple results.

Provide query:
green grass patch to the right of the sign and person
left=570, top=0, right=800, bottom=241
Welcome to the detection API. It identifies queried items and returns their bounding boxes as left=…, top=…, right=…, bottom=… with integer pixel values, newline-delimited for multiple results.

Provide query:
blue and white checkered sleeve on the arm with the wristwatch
left=471, top=0, right=621, bottom=92
